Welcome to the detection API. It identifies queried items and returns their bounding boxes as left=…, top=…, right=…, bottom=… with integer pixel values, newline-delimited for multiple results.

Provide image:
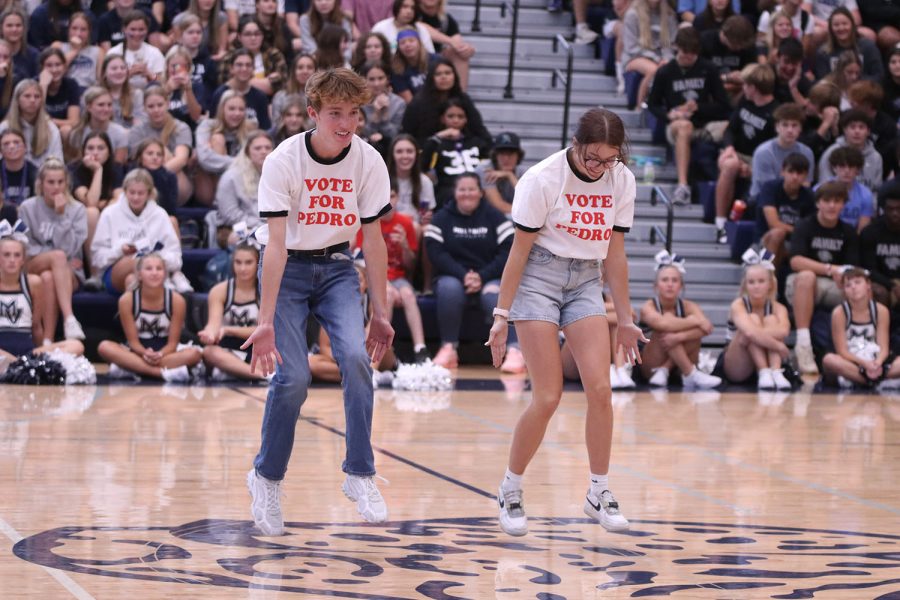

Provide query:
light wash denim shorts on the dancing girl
left=509, top=244, right=606, bottom=328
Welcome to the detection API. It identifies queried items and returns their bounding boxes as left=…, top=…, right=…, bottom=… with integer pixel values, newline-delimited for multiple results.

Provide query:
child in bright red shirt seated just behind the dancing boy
left=356, top=182, right=430, bottom=364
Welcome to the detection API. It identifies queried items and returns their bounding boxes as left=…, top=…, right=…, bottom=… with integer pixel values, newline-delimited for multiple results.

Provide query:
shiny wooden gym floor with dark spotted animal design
left=0, top=369, right=900, bottom=600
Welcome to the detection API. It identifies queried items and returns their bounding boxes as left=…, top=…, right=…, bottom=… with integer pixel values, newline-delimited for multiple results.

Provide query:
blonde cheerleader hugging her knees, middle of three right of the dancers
left=640, top=251, right=722, bottom=389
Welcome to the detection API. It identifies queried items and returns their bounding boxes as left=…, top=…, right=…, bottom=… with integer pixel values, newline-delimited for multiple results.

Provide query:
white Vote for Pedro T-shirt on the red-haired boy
left=255, top=131, right=391, bottom=250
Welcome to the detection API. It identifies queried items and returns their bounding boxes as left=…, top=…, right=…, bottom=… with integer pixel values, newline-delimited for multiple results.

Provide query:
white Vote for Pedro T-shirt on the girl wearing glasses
left=512, top=148, right=636, bottom=260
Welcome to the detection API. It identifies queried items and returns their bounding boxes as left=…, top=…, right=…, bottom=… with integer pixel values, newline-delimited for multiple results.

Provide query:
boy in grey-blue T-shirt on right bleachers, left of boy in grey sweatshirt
left=750, top=103, right=815, bottom=202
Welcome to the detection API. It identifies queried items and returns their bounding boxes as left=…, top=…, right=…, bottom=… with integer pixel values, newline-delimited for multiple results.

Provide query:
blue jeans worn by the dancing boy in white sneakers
left=254, top=251, right=375, bottom=481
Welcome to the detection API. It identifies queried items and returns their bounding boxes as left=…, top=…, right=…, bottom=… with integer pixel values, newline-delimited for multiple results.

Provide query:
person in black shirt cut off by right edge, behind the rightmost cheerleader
left=860, top=179, right=900, bottom=307
